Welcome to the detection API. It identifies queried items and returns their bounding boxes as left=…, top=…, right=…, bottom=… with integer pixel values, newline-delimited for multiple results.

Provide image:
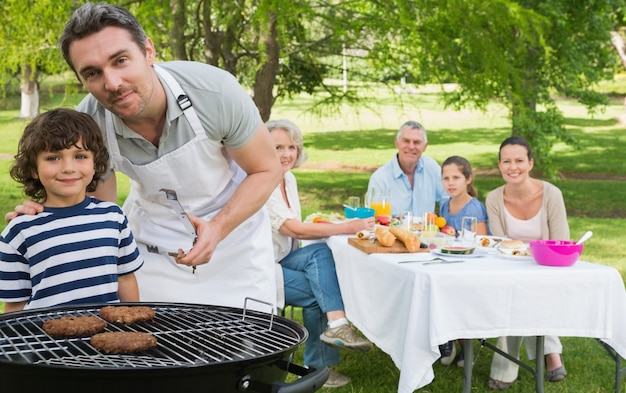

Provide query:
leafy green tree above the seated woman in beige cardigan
left=370, top=0, right=624, bottom=174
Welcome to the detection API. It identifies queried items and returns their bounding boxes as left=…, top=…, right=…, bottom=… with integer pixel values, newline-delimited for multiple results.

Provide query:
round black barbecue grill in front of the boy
left=0, top=303, right=328, bottom=393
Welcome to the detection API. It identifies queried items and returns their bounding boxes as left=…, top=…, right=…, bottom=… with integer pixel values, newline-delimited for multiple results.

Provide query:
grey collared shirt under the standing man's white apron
left=76, top=61, right=261, bottom=169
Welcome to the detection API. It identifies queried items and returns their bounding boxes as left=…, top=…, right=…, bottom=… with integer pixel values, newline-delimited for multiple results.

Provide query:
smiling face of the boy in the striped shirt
left=33, top=140, right=96, bottom=207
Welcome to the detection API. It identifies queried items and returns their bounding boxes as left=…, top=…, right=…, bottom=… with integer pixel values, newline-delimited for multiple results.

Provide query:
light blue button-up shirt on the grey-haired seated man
left=367, top=153, right=450, bottom=217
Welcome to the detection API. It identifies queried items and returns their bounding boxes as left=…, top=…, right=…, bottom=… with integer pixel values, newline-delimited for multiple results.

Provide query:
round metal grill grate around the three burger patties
left=0, top=304, right=306, bottom=369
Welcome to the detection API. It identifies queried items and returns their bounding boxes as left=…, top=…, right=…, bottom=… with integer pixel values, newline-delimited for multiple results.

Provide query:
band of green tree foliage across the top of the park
left=0, top=0, right=626, bottom=175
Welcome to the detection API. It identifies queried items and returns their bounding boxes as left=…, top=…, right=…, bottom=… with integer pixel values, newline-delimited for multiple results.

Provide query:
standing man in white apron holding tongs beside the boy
left=7, top=3, right=281, bottom=310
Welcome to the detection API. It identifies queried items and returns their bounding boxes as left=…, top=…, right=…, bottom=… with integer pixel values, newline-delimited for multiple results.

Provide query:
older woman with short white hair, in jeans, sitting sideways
left=266, top=120, right=374, bottom=387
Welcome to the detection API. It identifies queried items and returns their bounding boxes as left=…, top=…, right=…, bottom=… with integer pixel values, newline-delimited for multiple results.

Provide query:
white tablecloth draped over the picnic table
left=327, top=236, right=626, bottom=393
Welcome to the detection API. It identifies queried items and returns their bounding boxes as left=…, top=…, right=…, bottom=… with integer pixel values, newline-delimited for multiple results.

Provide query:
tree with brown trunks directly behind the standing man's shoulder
left=131, top=0, right=361, bottom=120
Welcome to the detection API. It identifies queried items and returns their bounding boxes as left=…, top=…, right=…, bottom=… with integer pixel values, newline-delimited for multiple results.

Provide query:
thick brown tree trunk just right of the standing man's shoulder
left=254, top=11, right=280, bottom=121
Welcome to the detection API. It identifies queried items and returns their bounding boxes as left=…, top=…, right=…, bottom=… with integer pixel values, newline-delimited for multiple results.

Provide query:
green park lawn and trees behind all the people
left=0, top=0, right=626, bottom=393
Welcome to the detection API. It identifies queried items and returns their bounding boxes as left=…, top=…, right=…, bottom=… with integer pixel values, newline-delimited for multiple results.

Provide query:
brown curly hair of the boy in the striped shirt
left=9, top=108, right=109, bottom=201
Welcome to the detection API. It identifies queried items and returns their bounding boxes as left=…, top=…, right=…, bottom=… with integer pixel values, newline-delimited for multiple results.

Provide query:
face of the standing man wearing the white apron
left=69, top=27, right=156, bottom=119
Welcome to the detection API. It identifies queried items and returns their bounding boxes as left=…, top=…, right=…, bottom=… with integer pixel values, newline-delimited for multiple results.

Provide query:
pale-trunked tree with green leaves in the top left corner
left=0, top=0, right=71, bottom=118
